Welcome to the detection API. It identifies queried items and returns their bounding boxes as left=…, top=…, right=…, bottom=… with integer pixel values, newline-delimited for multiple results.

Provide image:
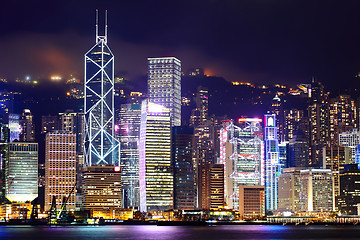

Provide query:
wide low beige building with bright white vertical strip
left=299, top=169, right=335, bottom=212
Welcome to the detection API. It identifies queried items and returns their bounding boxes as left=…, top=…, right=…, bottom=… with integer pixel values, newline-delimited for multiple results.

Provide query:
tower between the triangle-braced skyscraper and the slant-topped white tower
left=119, top=103, right=141, bottom=208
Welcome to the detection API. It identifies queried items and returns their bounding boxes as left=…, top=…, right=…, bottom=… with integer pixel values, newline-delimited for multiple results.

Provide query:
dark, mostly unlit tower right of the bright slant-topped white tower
left=172, top=127, right=195, bottom=210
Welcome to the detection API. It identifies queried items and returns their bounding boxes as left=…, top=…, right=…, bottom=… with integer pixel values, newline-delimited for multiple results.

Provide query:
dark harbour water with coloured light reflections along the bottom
left=0, top=225, right=360, bottom=240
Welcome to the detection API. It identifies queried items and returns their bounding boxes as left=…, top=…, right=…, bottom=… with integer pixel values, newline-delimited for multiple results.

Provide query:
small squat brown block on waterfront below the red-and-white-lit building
left=239, top=185, right=265, bottom=219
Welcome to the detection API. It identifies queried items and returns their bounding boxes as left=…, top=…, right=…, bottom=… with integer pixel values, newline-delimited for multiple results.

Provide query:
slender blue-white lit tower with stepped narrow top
left=264, top=114, right=281, bottom=211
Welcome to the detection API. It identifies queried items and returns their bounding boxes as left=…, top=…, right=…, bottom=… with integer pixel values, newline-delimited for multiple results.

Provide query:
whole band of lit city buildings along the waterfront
left=0, top=15, right=360, bottom=223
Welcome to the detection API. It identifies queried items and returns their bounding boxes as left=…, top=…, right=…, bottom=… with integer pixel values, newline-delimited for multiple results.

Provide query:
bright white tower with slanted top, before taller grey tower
left=139, top=100, right=174, bottom=212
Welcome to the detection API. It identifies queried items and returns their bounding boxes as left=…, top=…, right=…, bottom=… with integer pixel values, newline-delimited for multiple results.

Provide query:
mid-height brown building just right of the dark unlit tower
left=198, top=164, right=225, bottom=209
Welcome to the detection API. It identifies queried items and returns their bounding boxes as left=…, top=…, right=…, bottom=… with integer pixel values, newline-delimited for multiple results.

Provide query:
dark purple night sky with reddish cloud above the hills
left=0, top=0, right=360, bottom=88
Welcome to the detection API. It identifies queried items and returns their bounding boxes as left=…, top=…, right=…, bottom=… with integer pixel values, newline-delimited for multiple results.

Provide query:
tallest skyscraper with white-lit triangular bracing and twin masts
left=84, top=12, right=120, bottom=166
